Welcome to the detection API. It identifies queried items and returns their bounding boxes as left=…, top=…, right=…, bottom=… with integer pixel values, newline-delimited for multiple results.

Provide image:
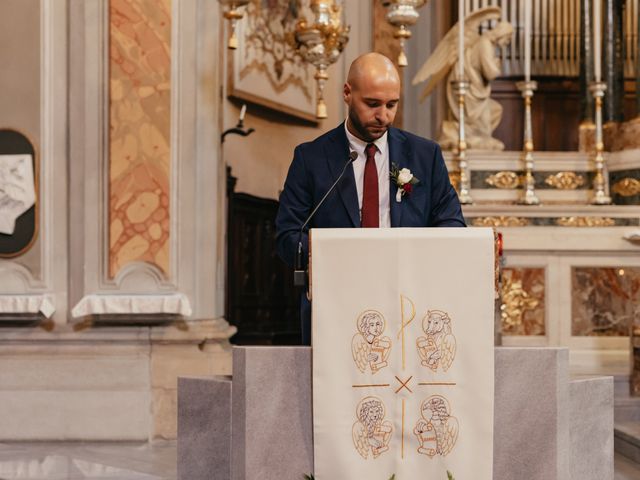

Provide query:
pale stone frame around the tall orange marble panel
left=69, top=0, right=225, bottom=318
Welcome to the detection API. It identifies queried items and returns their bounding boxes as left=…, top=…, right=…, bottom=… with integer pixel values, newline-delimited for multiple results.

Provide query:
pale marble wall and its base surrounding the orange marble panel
left=0, top=0, right=235, bottom=440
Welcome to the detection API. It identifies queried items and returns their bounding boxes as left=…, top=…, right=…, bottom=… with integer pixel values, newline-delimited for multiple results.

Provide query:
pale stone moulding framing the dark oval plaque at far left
left=0, top=0, right=67, bottom=322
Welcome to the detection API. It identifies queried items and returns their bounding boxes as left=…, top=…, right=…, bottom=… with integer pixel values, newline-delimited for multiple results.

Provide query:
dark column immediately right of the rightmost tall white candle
left=603, top=0, right=624, bottom=123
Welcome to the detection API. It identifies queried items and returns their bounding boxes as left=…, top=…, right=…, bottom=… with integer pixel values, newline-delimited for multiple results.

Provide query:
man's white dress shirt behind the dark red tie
left=344, top=121, right=391, bottom=228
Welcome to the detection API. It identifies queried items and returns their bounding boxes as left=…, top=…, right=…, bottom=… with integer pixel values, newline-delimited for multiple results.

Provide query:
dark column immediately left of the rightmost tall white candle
left=578, top=0, right=593, bottom=124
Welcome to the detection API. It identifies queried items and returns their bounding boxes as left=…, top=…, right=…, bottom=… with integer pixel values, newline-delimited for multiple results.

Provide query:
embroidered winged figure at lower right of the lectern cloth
left=413, top=395, right=458, bottom=458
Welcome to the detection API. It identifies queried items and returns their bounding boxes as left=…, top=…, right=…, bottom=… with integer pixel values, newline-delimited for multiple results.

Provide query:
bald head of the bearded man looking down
left=344, top=53, right=400, bottom=142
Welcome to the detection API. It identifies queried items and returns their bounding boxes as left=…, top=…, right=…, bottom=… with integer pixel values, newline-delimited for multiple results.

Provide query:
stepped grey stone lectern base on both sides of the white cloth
left=178, top=347, right=613, bottom=480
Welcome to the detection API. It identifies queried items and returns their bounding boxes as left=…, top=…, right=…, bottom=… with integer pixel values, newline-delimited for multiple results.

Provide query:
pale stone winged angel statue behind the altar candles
left=412, top=7, right=513, bottom=150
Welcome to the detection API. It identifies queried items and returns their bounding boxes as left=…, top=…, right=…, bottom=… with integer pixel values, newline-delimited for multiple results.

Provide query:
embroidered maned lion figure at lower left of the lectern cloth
left=351, top=397, right=393, bottom=459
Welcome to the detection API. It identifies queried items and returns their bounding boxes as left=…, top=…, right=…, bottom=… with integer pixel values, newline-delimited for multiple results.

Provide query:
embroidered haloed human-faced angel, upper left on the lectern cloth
left=351, top=310, right=391, bottom=373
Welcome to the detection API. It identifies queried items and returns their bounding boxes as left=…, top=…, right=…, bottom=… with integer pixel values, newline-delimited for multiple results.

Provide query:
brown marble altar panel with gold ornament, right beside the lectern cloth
left=500, top=268, right=545, bottom=335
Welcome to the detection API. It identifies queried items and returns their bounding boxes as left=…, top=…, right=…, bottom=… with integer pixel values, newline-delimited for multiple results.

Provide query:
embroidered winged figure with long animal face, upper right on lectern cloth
left=416, top=310, right=456, bottom=372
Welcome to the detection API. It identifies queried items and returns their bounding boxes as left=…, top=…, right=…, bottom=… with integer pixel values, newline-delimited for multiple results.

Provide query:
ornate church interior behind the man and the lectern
left=0, top=0, right=640, bottom=480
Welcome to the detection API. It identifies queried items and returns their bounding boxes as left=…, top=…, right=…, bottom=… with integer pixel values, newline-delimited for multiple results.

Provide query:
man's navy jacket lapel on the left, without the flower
left=326, top=123, right=360, bottom=227
